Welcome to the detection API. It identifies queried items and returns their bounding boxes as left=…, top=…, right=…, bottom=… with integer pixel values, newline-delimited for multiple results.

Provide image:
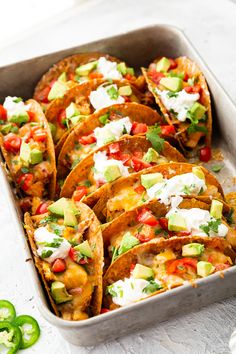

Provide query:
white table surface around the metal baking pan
left=0, top=0, right=236, bottom=354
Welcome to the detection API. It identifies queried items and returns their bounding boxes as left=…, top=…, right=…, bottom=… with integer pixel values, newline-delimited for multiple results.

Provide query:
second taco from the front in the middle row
left=103, top=197, right=236, bottom=264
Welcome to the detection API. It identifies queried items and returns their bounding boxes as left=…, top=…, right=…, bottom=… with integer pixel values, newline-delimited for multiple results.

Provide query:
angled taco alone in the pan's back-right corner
left=142, top=57, right=212, bottom=153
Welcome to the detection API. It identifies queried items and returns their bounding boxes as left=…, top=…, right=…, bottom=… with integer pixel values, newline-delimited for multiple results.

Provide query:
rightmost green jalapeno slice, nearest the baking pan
left=14, top=315, right=40, bottom=349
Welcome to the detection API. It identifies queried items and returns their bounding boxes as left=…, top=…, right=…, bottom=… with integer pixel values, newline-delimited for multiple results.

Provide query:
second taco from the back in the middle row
left=45, top=79, right=142, bottom=152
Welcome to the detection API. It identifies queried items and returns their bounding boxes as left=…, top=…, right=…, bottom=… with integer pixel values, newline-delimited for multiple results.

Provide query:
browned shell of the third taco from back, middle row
left=58, top=102, right=162, bottom=178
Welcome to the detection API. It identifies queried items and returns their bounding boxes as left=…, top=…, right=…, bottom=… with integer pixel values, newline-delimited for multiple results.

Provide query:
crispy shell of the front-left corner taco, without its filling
left=24, top=203, right=103, bottom=320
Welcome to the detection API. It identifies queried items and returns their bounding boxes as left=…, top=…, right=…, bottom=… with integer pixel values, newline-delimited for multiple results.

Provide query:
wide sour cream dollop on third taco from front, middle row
left=147, top=172, right=206, bottom=205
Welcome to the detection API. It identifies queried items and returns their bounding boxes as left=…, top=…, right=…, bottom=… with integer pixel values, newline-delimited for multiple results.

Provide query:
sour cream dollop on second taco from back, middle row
left=89, top=84, right=125, bottom=110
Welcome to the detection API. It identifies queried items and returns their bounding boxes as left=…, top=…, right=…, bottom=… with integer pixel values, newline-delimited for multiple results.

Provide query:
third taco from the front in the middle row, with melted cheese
left=91, top=162, right=224, bottom=222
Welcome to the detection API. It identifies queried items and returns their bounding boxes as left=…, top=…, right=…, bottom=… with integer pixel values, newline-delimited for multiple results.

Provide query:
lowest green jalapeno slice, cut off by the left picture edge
left=0, top=321, right=21, bottom=354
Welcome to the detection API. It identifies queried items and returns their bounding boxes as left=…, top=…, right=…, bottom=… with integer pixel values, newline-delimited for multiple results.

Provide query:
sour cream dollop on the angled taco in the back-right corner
left=156, top=89, right=200, bottom=122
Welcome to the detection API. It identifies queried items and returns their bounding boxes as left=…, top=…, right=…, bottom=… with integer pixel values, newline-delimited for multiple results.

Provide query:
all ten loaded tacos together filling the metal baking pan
left=0, top=53, right=236, bottom=321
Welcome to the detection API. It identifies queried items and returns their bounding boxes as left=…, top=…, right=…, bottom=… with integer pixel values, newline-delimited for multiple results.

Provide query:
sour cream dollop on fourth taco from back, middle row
left=93, top=151, right=129, bottom=183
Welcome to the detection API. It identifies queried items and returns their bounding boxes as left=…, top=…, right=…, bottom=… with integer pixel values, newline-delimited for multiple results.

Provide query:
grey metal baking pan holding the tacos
left=0, top=25, right=236, bottom=346
